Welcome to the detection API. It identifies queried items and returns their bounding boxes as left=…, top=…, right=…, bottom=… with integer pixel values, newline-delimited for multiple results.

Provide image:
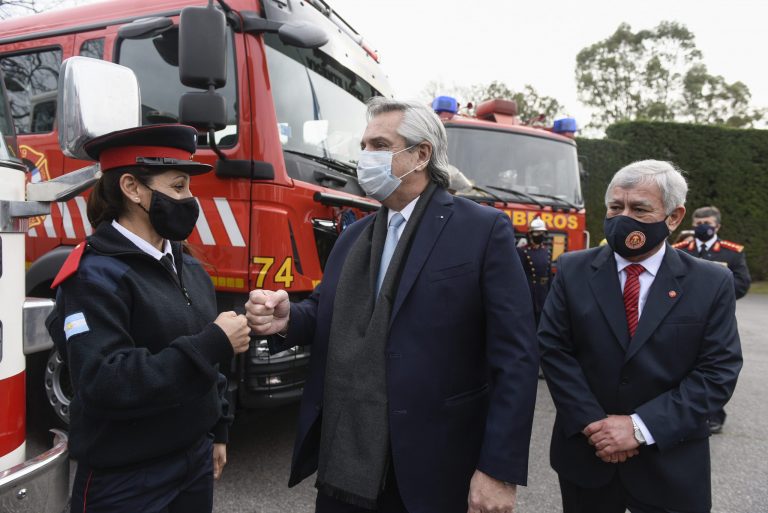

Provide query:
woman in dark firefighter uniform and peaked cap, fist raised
left=49, top=125, right=250, bottom=513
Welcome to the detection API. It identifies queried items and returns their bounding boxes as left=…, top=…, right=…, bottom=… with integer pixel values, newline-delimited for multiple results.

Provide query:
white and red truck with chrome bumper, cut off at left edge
left=0, top=65, right=69, bottom=513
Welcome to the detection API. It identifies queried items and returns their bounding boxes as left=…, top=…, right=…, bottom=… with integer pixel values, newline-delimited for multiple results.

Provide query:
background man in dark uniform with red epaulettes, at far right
left=674, top=206, right=752, bottom=434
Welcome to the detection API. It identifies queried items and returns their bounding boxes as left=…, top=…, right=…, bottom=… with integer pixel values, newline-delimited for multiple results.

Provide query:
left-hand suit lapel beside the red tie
left=589, top=245, right=629, bottom=350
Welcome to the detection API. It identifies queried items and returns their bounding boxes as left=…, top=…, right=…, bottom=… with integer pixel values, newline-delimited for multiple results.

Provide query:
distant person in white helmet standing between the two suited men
left=517, top=217, right=552, bottom=326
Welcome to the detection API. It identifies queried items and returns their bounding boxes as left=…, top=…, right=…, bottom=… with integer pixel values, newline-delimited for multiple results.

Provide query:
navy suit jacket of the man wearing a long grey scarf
left=273, top=189, right=538, bottom=513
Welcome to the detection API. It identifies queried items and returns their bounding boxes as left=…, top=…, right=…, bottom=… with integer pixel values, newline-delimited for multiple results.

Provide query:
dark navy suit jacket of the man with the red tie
left=539, top=246, right=742, bottom=511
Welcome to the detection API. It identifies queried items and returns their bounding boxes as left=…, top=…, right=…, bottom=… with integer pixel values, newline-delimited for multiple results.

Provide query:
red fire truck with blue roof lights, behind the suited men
left=432, top=96, right=589, bottom=261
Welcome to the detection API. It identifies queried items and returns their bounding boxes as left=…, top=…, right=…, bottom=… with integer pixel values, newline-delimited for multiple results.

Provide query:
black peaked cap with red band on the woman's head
left=85, top=125, right=212, bottom=175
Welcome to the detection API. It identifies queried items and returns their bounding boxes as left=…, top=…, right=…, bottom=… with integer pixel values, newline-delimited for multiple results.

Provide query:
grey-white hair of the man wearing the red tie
left=605, top=160, right=688, bottom=215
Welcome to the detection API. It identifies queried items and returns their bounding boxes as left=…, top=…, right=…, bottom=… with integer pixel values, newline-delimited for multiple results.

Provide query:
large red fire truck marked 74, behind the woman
left=0, top=0, right=391, bottom=420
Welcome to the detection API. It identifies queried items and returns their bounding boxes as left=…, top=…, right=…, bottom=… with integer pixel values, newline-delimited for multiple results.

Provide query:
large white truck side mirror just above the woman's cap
left=56, top=57, right=141, bottom=160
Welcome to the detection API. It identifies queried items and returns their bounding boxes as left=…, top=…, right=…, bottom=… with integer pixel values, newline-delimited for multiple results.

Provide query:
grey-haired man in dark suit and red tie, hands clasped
left=539, top=160, right=742, bottom=513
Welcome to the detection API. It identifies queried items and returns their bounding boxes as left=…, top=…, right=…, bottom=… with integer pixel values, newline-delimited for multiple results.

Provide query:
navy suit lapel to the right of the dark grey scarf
left=390, top=188, right=453, bottom=324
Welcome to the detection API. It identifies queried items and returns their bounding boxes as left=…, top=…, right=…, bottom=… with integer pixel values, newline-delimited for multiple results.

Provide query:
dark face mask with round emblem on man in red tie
left=603, top=215, right=669, bottom=258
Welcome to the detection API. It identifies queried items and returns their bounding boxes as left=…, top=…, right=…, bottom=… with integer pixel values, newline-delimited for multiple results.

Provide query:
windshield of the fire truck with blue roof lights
left=446, top=125, right=584, bottom=205
